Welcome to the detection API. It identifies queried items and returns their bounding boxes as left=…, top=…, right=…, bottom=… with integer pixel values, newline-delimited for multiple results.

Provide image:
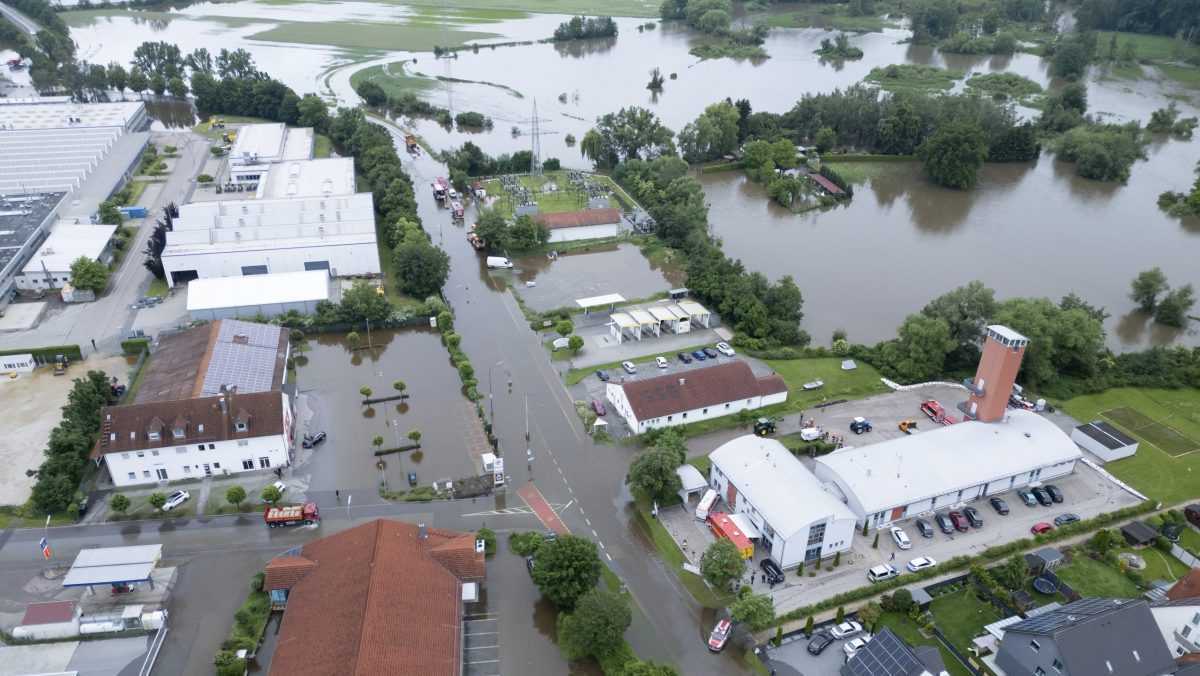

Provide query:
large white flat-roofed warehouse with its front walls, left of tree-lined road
left=162, top=192, right=379, bottom=286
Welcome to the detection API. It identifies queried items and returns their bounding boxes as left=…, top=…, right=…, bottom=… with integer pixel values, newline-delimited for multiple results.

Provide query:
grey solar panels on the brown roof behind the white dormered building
left=200, top=319, right=282, bottom=395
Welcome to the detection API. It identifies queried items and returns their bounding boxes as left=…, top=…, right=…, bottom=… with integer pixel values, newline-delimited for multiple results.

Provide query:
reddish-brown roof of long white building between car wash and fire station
left=620, top=360, right=787, bottom=420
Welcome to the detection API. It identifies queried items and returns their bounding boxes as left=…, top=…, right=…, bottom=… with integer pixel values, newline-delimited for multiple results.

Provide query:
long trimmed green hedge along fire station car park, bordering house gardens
left=775, top=501, right=1157, bottom=624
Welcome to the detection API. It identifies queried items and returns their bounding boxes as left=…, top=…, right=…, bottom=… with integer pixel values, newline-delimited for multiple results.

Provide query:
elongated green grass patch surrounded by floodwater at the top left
left=248, top=22, right=498, bottom=52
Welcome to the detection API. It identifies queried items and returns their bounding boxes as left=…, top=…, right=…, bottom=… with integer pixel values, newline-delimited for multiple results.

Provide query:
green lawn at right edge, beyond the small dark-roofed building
left=1062, top=388, right=1200, bottom=504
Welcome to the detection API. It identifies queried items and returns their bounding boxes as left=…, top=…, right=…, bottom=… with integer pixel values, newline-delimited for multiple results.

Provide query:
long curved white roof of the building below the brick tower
left=817, top=409, right=1082, bottom=514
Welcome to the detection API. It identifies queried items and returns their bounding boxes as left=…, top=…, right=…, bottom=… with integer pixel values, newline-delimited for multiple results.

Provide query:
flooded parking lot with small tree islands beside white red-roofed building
left=296, top=329, right=478, bottom=497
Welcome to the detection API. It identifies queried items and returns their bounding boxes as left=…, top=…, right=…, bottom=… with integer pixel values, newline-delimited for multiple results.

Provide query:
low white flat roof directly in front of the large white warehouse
left=187, top=270, right=329, bottom=312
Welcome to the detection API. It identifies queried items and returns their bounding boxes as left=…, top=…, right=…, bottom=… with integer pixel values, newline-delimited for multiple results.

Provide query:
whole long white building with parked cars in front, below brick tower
left=815, top=409, right=1082, bottom=528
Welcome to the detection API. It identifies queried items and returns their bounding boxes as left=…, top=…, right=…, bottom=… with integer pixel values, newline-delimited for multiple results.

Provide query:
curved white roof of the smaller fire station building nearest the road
left=708, top=435, right=854, bottom=539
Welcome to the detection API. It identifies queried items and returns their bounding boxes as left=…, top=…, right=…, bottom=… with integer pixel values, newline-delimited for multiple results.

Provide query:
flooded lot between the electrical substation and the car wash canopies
left=501, top=243, right=683, bottom=311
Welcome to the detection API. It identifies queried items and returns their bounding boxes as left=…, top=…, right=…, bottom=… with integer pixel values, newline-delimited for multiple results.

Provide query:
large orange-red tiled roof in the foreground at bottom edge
left=268, top=519, right=485, bottom=676
